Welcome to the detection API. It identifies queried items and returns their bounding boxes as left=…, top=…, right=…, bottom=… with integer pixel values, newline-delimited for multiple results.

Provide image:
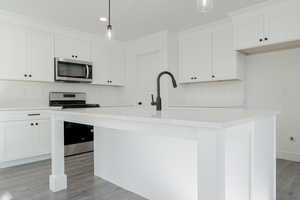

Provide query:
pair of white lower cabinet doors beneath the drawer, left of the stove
left=0, top=115, right=51, bottom=164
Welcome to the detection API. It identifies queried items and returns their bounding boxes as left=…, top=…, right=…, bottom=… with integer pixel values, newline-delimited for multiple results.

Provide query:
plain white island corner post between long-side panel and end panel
left=197, top=128, right=225, bottom=200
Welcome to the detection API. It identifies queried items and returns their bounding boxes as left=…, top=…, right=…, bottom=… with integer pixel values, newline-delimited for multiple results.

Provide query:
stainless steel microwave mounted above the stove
left=54, top=58, right=93, bottom=83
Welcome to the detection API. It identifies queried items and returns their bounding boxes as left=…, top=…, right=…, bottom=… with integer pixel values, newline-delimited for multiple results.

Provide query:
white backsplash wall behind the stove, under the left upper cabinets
left=0, top=81, right=128, bottom=107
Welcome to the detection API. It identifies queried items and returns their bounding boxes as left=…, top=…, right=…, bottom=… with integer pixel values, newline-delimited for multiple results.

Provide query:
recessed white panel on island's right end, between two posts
left=225, top=122, right=254, bottom=200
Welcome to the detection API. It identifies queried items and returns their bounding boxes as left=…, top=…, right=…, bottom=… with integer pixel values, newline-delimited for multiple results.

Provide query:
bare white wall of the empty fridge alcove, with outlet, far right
left=246, top=49, right=300, bottom=161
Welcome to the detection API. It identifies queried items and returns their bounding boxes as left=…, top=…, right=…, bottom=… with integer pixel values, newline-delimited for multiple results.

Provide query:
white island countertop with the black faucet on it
left=50, top=107, right=278, bottom=128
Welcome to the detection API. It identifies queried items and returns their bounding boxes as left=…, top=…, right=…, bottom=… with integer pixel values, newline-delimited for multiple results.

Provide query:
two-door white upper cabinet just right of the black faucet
left=179, top=23, right=243, bottom=83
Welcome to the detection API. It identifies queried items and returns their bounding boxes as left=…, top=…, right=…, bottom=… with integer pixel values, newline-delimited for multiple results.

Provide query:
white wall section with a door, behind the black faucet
left=125, top=32, right=168, bottom=108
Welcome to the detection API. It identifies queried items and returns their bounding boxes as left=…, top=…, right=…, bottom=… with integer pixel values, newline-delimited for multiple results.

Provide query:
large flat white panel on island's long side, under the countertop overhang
left=95, top=127, right=198, bottom=200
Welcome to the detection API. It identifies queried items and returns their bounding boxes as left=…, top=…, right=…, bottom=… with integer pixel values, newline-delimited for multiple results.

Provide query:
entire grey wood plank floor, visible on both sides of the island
left=0, top=153, right=300, bottom=200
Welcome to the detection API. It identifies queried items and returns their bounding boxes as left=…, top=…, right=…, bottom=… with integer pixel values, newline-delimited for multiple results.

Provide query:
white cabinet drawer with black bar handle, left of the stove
left=0, top=110, right=50, bottom=122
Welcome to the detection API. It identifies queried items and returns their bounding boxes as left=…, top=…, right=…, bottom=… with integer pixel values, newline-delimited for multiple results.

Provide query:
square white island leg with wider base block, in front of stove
left=49, top=116, right=67, bottom=192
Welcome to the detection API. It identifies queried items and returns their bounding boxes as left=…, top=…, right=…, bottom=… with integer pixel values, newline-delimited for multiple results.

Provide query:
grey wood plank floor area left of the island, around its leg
left=0, top=153, right=145, bottom=200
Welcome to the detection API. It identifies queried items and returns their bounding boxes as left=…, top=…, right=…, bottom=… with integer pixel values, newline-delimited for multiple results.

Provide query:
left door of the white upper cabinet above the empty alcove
left=234, top=15, right=264, bottom=50
